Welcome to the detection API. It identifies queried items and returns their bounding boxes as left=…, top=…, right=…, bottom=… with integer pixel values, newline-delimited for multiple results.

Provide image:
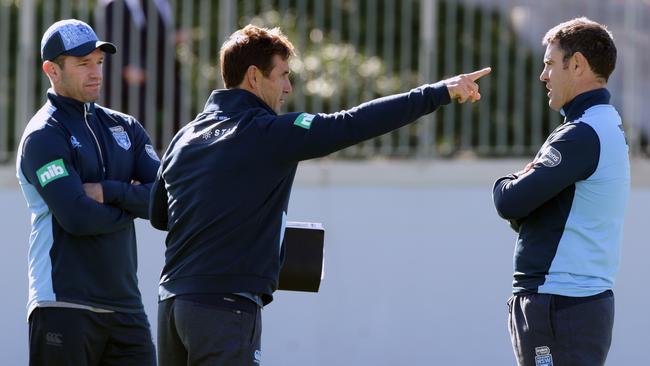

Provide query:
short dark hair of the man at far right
left=542, top=17, right=616, bottom=81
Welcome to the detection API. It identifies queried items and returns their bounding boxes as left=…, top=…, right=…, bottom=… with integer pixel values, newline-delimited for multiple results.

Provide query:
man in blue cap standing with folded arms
left=16, top=19, right=160, bottom=365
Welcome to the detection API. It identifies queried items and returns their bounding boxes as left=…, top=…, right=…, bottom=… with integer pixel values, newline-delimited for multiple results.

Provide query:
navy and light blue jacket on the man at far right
left=493, top=89, right=630, bottom=297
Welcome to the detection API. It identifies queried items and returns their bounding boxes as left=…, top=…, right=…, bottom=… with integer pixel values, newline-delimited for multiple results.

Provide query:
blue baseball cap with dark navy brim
left=41, top=19, right=117, bottom=61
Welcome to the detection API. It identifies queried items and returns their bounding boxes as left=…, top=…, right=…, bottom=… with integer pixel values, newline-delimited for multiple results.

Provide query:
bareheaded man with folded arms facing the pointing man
left=493, top=18, right=630, bottom=366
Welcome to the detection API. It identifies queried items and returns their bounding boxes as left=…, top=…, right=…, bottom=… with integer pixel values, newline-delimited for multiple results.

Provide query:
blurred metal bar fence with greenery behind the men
left=0, top=0, right=650, bottom=161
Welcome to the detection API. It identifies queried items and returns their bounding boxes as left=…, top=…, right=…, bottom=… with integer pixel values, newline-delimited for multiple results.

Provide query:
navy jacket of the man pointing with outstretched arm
left=150, top=84, right=450, bottom=303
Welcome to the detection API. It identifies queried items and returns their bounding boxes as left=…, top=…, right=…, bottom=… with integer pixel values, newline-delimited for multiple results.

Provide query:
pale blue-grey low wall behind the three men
left=0, top=160, right=650, bottom=366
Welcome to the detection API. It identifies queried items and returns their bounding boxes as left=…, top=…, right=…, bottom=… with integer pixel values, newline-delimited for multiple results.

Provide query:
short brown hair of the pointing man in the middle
left=219, top=24, right=295, bottom=88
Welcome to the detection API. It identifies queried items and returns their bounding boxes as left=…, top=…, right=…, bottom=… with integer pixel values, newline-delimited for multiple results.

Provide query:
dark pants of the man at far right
left=508, top=291, right=614, bottom=366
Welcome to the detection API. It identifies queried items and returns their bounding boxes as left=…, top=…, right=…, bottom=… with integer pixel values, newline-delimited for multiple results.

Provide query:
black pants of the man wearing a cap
left=29, top=307, right=156, bottom=366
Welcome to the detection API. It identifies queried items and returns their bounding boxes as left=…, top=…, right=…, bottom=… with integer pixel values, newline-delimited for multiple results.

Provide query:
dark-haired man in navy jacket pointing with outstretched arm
left=150, top=25, right=490, bottom=366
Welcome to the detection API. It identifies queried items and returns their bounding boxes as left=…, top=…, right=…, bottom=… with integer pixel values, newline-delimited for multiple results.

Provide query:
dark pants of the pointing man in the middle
left=158, top=295, right=262, bottom=366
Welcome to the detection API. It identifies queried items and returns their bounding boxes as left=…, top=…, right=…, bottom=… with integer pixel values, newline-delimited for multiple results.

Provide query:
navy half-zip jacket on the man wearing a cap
left=16, top=91, right=160, bottom=312
